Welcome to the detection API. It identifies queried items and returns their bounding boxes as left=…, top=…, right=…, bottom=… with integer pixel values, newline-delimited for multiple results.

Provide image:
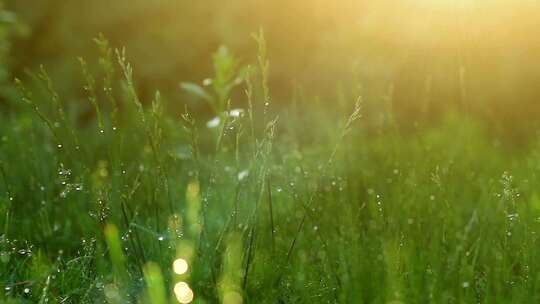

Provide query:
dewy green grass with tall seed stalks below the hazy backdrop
left=0, top=34, right=540, bottom=304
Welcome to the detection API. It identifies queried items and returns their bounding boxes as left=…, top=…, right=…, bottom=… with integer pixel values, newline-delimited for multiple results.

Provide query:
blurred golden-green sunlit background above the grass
left=1, top=0, right=540, bottom=142
